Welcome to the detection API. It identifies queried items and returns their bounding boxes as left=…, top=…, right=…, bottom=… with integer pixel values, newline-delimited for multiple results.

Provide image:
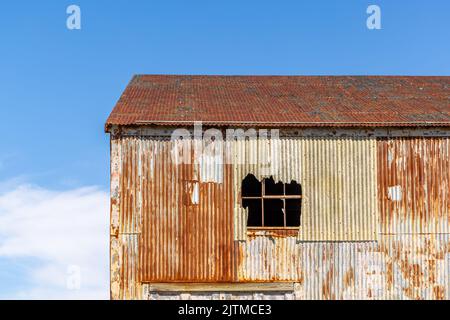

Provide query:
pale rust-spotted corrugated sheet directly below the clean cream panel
left=287, top=242, right=381, bottom=300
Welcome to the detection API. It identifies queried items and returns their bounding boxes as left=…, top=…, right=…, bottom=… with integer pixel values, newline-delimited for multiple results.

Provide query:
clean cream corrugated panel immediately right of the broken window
left=299, top=138, right=377, bottom=241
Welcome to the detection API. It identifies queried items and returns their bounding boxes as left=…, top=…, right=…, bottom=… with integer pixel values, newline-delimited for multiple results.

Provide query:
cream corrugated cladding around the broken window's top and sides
left=233, top=137, right=377, bottom=241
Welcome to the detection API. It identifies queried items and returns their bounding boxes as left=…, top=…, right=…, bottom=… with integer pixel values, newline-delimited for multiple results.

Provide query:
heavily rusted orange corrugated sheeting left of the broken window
left=120, top=137, right=235, bottom=282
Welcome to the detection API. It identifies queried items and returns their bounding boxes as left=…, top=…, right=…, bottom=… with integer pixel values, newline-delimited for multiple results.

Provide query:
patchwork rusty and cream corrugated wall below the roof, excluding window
left=111, top=130, right=450, bottom=299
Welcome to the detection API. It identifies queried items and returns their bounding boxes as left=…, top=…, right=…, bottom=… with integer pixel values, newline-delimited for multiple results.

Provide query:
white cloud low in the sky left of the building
left=0, top=185, right=109, bottom=299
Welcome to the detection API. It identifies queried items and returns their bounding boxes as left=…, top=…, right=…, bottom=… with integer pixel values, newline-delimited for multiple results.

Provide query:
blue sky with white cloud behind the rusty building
left=0, top=0, right=450, bottom=298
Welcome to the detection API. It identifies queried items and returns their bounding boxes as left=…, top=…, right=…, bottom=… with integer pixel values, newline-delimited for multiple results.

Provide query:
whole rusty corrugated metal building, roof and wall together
left=106, top=75, right=450, bottom=299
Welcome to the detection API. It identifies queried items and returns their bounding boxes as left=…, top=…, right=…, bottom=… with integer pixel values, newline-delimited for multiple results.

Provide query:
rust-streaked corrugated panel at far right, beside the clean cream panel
left=378, top=138, right=450, bottom=234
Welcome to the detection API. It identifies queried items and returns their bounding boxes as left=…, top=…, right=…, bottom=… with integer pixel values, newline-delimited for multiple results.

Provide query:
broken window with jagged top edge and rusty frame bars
left=241, top=174, right=302, bottom=227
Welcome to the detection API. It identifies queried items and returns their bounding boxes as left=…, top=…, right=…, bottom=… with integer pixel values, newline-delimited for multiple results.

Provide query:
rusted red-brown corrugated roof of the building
left=106, top=75, right=450, bottom=130
